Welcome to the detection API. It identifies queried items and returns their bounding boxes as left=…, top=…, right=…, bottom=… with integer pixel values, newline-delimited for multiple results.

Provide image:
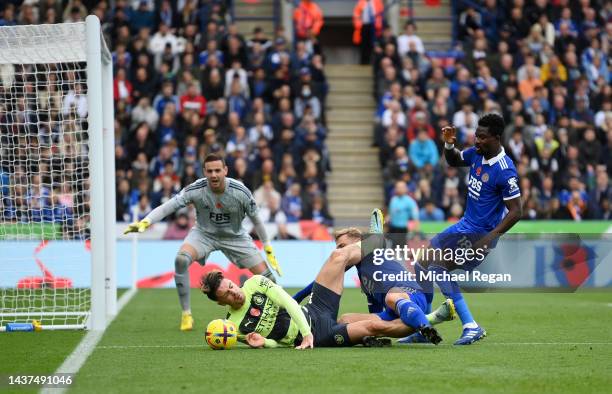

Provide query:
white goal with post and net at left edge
left=0, top=16, right=117, bottom=331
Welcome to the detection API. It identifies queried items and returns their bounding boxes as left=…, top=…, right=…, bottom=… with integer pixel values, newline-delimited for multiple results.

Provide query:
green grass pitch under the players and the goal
left=0, top=289, right=612, bottom=393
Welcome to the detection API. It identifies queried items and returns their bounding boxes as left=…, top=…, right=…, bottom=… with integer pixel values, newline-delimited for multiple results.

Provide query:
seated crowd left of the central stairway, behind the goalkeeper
left=0, top=0, right=333, bottom=237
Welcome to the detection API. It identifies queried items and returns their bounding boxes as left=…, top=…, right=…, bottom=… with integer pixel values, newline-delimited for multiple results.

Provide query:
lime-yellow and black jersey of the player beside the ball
left=228, top=275, right=310, bottom=347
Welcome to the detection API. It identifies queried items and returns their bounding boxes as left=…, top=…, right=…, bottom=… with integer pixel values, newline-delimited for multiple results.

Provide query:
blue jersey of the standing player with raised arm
left=461, top=147, right=521, bottom=233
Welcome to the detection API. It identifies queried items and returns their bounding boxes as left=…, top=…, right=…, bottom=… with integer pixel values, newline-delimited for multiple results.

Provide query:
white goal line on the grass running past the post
left=40, top=289, right=136, bottom=394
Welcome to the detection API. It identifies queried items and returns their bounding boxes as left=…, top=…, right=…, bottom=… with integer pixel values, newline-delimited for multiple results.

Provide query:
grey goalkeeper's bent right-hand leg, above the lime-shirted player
left=217, top=237, right=276, bottom=282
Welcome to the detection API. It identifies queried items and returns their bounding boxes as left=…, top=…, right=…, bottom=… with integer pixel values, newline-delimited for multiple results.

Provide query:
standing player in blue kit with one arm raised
left=400, top=113, right=523, bottom=345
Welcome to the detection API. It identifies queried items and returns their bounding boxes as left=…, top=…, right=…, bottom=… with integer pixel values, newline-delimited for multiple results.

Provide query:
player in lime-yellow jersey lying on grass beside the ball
left=201, top=231, right=450, bottom=349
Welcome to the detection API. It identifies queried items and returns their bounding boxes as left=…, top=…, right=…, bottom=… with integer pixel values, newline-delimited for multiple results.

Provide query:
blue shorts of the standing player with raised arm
left=431, top=220, right=487, bottom=271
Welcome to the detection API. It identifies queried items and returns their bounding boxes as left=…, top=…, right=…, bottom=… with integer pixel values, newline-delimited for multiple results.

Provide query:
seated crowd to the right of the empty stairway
left=373, top=0, right=612, bottom=230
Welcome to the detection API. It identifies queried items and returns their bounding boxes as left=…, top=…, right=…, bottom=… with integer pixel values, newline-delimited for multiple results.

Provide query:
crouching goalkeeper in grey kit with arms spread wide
left=124, top=154, right=282, bottom=331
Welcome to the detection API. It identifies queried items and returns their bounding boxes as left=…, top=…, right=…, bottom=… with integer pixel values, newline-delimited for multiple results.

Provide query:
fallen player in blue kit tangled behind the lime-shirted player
left=293, top=209, right=455, bottom=342
